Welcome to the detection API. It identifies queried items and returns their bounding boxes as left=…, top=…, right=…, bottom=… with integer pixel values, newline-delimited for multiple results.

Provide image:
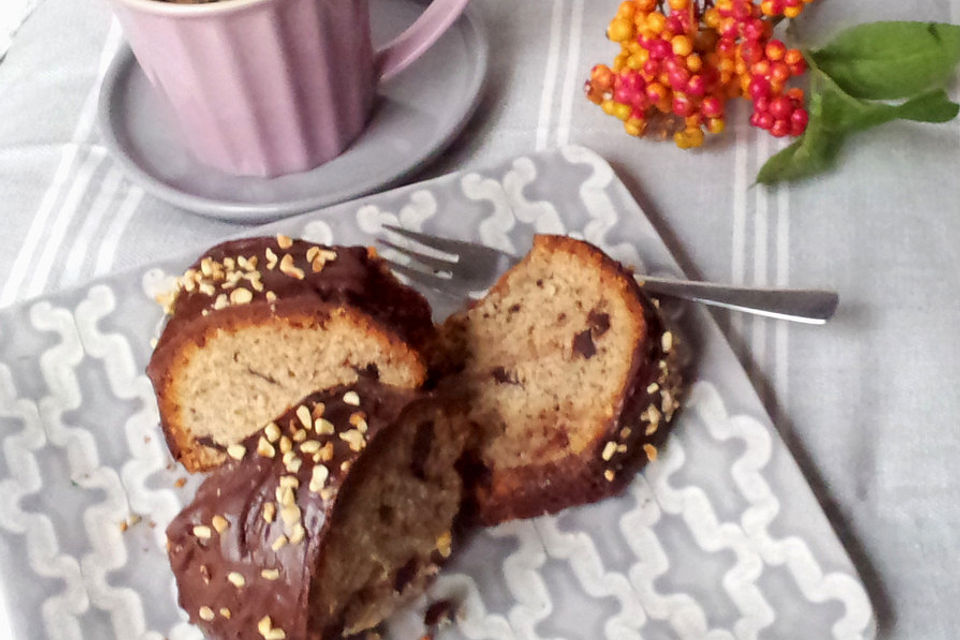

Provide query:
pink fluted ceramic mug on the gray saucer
left=111, top=0, right=469, bottom=176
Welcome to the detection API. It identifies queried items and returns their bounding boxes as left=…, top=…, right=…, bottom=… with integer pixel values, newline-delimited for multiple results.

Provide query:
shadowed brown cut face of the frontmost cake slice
left=310, top=408, right=465, bottom=636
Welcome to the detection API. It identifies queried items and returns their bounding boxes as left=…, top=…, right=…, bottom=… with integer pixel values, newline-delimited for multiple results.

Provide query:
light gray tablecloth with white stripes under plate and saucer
left=0, top=0, right=960, bottom=640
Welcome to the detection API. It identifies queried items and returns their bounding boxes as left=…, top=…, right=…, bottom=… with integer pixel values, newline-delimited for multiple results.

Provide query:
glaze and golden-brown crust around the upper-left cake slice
left=147, top=236, right=435, bottom=471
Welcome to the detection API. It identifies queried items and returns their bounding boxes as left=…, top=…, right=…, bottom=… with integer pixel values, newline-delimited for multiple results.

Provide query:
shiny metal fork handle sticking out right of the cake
left=637, top=275, right=840, bottom=324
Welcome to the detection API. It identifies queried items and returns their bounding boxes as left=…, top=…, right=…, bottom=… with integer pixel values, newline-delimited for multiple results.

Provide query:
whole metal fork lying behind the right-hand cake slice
left=380, top=225, right=839, bottom=324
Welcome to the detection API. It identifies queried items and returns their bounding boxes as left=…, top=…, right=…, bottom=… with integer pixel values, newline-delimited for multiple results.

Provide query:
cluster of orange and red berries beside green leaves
left=585, top=0, right=812, bottom=149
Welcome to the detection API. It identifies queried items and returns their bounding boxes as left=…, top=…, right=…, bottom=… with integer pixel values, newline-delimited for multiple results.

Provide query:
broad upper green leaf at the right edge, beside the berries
left=808, top=22, right=960, bottom=100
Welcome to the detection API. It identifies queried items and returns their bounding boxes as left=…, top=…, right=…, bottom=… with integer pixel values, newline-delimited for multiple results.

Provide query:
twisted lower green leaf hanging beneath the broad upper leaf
left=757, top=70, right=960, bottom=184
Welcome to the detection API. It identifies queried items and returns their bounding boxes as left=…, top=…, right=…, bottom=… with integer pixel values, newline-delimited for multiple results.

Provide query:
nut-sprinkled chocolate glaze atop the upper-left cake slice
left=157, top=236, right=432, bottom=350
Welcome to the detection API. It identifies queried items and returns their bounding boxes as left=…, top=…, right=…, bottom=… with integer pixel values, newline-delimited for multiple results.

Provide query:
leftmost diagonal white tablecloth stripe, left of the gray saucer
left=0, top=22, right=121, bottom=307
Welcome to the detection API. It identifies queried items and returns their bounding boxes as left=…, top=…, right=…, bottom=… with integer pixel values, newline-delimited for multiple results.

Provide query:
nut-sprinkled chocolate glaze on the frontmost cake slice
left=167, top=379, right=416, bottom=640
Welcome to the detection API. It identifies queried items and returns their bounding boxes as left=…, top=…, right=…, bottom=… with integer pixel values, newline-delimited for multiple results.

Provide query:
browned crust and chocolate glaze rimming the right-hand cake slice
left=440, top=235, right=680, bottom=524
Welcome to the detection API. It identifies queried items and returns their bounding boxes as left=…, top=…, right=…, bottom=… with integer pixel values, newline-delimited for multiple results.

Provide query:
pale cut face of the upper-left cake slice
left=169, top=313, right=423, bottom=464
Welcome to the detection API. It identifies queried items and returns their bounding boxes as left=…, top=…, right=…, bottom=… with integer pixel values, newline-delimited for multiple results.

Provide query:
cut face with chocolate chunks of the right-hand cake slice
left=443, top=242, right=645, bottom=470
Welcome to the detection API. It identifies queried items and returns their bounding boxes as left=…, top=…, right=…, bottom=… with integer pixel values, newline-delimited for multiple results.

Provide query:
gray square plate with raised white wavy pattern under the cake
left=0, top=147, right=875, bottom=640
